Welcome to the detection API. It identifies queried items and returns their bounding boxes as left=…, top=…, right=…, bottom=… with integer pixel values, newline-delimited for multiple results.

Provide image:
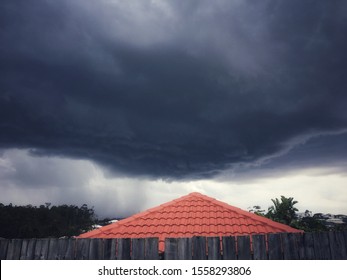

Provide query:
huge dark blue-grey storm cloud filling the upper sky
left=0, top=0, right=347, bottom=179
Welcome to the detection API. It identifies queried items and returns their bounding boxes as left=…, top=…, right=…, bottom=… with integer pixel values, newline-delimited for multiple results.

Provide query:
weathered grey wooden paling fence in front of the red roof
left=0, top=231, right=347, bottom=260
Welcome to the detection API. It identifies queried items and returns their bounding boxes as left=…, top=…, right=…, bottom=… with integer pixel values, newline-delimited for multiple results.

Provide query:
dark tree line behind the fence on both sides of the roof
left=0, top=196, right=347, bottom=238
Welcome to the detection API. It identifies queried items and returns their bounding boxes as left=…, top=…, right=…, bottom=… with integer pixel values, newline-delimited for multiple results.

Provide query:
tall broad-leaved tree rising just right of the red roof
left=265, top=195, right=298, bottom=225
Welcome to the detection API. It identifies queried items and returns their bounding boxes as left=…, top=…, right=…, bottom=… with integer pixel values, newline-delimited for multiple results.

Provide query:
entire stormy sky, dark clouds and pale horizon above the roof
left=0, top=0, right=347, bottom=217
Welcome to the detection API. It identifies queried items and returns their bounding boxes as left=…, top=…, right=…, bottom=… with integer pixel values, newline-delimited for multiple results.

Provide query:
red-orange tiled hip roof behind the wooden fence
left=78, top=192, right=302, bottom=251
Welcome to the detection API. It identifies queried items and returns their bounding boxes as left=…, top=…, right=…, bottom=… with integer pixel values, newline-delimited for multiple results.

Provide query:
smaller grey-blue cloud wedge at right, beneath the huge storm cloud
left=218, top=130, right=347, bottom=184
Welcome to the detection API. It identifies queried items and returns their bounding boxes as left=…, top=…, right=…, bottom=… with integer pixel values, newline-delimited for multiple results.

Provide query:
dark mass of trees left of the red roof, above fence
left=0, top=203, right=96, bottom=238
